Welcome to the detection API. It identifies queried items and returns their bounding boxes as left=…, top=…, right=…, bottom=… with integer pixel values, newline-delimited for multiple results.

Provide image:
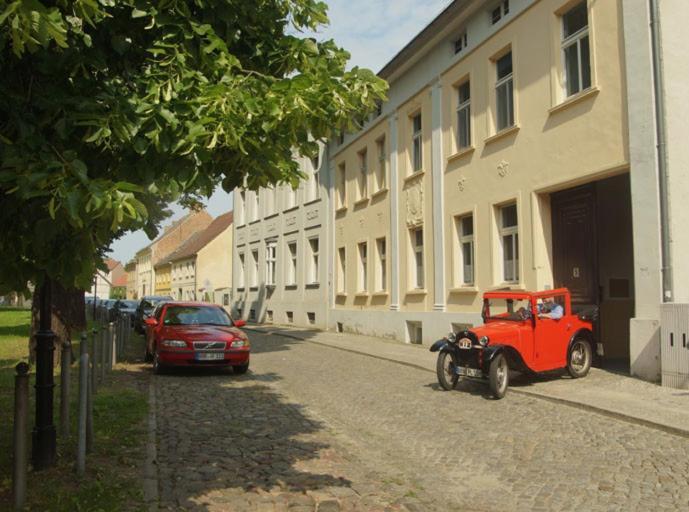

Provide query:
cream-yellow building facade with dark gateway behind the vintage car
left=326, top=0, right=689, bottom=380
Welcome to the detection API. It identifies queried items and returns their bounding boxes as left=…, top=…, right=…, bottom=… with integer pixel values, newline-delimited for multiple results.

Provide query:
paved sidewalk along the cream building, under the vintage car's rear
left=246, top=325, right=689, bottom=438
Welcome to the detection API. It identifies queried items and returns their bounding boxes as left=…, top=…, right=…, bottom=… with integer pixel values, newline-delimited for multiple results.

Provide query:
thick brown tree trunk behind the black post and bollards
left=29, top=281, right=86, bottom=366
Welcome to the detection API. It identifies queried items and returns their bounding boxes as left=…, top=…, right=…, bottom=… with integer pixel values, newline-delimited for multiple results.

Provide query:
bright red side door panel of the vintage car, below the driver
left=533, top=315, right=572, bottom=371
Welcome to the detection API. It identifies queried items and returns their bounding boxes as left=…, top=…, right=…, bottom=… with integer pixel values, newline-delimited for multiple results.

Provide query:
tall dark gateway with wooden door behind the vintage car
left=550, top=174, right=634, bottom=371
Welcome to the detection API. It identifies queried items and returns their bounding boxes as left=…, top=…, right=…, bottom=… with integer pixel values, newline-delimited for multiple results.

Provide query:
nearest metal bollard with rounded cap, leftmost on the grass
left=12, top=363, right=29, bottom=510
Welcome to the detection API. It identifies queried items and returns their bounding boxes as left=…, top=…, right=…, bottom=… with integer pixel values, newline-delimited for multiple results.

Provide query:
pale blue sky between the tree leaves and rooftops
left=111, top=0, right=450, bottom=263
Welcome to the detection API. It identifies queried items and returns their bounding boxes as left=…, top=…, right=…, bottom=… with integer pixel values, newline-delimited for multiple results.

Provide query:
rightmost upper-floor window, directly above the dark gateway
left=562, top=2, right=591, bottom=96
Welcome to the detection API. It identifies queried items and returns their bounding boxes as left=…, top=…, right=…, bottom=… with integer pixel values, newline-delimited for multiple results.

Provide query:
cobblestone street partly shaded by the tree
left=154, top=333, right=689, bottom=512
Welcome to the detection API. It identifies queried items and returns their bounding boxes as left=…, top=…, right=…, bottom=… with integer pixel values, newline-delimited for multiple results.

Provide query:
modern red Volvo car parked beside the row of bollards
left=146, top=302, right=250, bottom=373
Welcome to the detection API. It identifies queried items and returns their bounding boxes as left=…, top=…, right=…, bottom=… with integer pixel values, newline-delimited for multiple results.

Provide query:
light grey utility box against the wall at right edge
left=660, top=304, right=689, bottom=389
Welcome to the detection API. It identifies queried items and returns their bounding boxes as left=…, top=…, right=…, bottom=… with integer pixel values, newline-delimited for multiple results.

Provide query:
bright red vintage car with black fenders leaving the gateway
left=430, top=288, right=598, bottom=398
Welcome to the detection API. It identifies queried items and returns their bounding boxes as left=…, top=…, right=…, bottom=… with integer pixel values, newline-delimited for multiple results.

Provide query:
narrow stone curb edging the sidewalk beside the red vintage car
left=244, top=327, right=689, bottom=439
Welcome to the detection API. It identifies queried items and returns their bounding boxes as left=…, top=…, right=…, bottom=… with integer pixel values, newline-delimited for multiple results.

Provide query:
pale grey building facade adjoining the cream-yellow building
left=232, top=147, right=330, bottom=328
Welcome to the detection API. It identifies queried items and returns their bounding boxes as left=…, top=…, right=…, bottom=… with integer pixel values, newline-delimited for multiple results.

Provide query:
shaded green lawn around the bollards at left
left=0, top=308, right=148, bottom=511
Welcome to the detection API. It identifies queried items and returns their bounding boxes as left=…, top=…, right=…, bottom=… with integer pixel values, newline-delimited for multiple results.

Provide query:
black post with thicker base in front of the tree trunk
left=31, top=276, right=56, bottom=470
